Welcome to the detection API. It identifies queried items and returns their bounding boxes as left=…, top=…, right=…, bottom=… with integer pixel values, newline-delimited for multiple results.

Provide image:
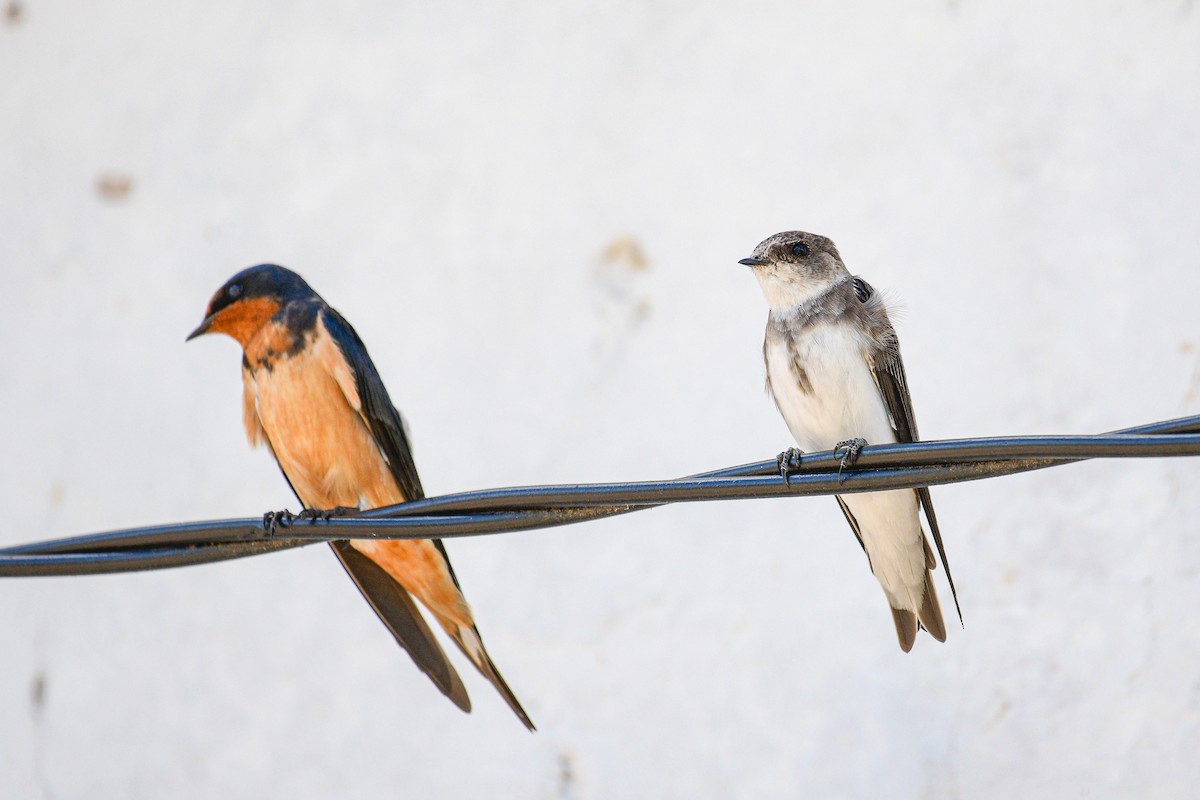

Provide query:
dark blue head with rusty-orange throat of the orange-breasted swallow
left=187, top=264, right=314, bottom=347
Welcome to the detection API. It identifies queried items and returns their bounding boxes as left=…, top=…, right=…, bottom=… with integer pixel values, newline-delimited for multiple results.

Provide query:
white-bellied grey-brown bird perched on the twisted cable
left=739, top=230, right=962, bottom=652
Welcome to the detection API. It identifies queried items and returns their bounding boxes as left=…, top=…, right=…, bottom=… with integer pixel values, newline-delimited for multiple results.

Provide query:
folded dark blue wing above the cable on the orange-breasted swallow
left=322, top=307, right=425, bottom=500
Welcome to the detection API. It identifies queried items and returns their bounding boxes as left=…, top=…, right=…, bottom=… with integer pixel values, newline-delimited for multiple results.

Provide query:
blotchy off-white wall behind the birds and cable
left=0, top=0, right=1200, bottom=800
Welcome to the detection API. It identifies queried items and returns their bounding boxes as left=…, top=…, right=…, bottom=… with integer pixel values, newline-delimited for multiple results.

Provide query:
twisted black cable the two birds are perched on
left=0, top=416, right=1200, bottom=577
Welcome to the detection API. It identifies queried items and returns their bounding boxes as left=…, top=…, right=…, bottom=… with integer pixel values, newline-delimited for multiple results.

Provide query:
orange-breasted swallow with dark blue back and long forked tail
left=187, top=264, right=534, bottom=730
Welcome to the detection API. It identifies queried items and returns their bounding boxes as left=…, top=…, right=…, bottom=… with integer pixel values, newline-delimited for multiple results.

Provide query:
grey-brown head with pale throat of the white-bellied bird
left=738, top=230, right=848, bottom=309
